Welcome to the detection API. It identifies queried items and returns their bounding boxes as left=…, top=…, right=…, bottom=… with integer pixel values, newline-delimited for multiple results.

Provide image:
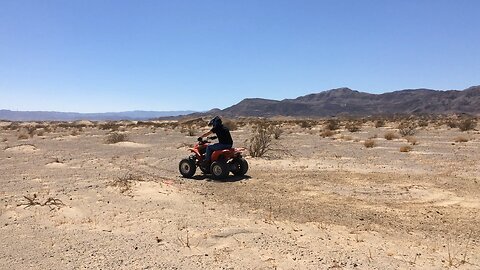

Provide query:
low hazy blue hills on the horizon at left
left=0, top=110, right=194, bottom=121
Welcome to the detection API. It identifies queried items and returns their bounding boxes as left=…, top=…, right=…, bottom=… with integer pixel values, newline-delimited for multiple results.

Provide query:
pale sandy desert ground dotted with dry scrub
left=0, top=121, right=480, bottom=269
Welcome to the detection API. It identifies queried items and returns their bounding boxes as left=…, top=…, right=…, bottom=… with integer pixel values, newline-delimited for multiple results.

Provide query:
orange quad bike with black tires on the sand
left=178, top=137, right=248, bottom=179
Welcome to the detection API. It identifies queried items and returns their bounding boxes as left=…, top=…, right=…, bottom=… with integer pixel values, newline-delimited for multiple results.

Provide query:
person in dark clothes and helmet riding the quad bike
left=198, top=116, right=233, bottom=165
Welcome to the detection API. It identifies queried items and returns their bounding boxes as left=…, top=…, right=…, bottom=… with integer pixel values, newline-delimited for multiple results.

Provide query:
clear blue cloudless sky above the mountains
left=0, top=0, right=480, bottom=112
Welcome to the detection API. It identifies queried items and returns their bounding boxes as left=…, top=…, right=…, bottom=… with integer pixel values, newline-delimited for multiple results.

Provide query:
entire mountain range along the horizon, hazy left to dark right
left=0, top=86, right=480, bottom=121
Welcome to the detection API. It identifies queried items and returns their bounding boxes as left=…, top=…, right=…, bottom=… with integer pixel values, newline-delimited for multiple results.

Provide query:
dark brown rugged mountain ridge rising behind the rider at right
left=215, top=86, right=480, bottom=117
